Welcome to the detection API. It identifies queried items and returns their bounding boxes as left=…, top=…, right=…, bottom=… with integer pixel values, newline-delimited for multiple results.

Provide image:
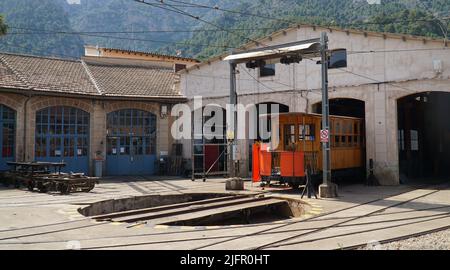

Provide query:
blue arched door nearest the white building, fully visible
left=106, top=109, right=156, bottom=175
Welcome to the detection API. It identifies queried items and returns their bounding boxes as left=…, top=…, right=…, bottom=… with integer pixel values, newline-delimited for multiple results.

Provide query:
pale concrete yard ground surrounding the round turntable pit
left=0, top=177, right=450, bottom=250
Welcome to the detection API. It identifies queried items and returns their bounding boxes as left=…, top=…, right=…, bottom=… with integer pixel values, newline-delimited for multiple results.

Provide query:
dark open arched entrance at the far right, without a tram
left=397, top=92, right=450, bottom=183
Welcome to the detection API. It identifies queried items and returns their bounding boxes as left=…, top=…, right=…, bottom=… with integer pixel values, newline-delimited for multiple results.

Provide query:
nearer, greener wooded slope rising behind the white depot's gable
left=162, top=0, right=450, bottom=59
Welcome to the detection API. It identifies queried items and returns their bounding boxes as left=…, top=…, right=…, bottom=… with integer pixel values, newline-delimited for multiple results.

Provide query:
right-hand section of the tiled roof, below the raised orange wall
left=84, top=58, right=180, bottom=97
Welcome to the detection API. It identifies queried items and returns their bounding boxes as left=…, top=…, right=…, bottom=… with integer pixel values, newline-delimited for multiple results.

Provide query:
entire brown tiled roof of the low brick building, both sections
left=0, top=53, right=181, bottom=98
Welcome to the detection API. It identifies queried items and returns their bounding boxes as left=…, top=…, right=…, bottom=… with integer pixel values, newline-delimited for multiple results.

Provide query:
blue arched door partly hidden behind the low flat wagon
left=35, top=106, right=89, bottom=174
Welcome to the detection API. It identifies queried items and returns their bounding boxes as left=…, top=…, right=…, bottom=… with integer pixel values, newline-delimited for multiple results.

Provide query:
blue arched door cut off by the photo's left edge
left=0, top=105, right=16, bottom=171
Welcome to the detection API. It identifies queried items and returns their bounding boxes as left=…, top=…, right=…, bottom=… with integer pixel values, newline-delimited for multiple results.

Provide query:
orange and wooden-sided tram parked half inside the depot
left=252, top=113, right=365, bottom=188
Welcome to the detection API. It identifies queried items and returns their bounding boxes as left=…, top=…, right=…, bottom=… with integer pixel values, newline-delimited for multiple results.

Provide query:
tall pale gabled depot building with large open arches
left=180, top=25, right=450, bottom=185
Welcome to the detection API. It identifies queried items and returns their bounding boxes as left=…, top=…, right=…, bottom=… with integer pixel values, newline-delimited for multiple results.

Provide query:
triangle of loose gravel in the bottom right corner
left=362, top=230, right=450, bottom=250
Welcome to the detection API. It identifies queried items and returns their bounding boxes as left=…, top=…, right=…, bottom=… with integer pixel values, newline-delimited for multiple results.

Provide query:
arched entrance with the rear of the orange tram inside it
left=312, top=98, right=366, bottom=184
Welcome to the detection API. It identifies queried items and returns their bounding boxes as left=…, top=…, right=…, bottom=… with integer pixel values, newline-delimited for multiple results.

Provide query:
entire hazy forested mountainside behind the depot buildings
left=0, top=0, right=450, bottom=59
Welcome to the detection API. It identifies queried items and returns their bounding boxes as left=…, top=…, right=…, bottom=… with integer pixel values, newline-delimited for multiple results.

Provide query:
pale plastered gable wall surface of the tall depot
left=180, top=27, right=450, bottom=185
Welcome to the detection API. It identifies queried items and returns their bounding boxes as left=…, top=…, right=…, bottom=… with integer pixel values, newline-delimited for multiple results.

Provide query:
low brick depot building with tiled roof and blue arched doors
left=0, top=46, right=197, bottom=175
